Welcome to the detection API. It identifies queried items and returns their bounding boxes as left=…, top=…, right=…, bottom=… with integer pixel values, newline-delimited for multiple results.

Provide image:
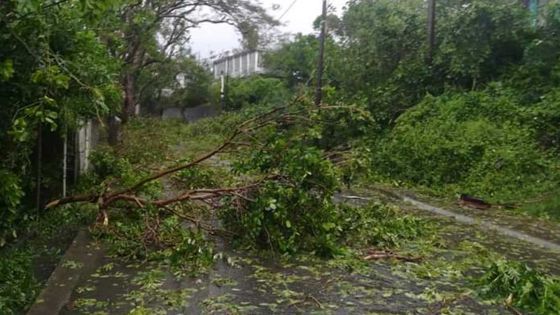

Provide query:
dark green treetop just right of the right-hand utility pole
left=434, top=0, right=533, bottom=88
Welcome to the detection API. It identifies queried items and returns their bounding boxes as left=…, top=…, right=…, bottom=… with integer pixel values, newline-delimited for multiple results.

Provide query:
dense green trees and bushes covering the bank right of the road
left=267, top=0, right=560, bottom=218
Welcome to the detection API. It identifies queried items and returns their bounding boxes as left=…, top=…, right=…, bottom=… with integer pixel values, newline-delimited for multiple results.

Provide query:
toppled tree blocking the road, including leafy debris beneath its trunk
left=47, top=98, right=380, bottom=265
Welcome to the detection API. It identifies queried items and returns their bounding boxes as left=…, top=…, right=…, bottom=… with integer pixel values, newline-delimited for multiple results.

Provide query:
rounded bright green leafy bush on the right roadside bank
left=372, top=89, right=559, bottom=199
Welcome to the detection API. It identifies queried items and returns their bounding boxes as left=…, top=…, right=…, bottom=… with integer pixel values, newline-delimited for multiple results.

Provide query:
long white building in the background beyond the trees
left=213, top=50, right=264, bottom=79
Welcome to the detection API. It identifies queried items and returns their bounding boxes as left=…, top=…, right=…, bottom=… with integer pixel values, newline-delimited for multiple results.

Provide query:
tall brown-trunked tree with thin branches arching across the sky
left=103, top=0, right=277, bottom=122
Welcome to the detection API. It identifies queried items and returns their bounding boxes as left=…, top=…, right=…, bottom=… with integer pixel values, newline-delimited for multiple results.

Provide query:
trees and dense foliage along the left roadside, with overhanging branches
left=0, top=0, right=276, bottom=246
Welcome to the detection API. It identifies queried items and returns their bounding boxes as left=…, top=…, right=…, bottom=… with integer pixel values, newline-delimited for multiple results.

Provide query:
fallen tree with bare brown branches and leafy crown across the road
left=48, top=99, right=374, bottom=256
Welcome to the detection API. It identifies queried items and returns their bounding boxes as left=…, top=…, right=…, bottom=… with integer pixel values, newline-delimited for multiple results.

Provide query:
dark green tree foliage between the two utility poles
left=337, top=0, right=435, bottom=126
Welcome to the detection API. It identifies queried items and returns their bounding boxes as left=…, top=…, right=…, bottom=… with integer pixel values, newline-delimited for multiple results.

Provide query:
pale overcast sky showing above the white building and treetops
left=191, top=0, right=347, bottom=58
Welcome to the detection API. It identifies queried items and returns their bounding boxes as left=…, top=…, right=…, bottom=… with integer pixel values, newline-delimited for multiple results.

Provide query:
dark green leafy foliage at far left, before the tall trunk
left=0, top=0, right=120, bottom=247
